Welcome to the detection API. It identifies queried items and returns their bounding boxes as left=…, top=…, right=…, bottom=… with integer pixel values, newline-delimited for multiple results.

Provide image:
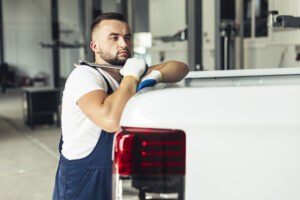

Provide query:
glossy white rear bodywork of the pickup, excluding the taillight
left=121, top=67, right=300, bottom=200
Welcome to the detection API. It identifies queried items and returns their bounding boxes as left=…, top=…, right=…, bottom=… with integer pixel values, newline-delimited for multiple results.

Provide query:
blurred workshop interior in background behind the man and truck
left=0, top=0, right=300, bottom=200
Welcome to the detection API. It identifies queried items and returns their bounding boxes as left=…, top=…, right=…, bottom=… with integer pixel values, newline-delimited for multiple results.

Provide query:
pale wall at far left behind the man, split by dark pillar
left=3, top=0, right=88, bottom=85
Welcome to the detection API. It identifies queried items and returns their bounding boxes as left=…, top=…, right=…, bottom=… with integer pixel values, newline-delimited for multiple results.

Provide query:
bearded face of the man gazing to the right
left=93, top=20, right=132, bottom=65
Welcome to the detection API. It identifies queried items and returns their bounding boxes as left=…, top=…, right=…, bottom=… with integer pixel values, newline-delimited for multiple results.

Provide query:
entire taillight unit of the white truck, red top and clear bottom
left=113, top=127, right=185, bottom=200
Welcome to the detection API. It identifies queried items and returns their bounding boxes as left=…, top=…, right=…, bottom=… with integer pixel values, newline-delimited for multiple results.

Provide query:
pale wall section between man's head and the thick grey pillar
left=149, top=0, right=187, bottom=64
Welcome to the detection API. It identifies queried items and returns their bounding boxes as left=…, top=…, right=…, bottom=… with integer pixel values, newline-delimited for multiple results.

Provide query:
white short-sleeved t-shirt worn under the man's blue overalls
left=61, top=65, right=119, bottom=160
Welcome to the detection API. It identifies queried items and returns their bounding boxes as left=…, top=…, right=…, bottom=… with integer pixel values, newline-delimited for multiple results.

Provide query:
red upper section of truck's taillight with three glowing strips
left=114, top=127, right=185, bottom=176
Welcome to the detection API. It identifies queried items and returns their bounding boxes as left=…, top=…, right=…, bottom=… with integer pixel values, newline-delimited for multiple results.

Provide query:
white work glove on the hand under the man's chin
left=120, top=58, right=148, bottom=82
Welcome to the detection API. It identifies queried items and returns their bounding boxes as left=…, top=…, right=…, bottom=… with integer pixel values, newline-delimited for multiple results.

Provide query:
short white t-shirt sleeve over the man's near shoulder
left=64, top=66, right=107, bottom=104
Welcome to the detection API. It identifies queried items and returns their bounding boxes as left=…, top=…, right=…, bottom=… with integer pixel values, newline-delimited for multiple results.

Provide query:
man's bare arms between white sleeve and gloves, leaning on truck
left=77, top=61, right=189, bottom=132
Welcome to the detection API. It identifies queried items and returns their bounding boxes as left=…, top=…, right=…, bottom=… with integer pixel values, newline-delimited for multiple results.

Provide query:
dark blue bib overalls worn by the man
left=52, top=68, right=114, bottom=200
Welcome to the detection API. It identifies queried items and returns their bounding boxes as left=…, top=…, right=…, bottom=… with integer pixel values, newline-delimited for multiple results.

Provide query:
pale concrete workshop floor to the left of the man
left=0, top=90, right=60, bottom=200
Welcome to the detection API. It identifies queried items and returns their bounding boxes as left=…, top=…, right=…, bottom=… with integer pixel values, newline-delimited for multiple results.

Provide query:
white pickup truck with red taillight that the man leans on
left=113, top=68, right=300, bottom=200
